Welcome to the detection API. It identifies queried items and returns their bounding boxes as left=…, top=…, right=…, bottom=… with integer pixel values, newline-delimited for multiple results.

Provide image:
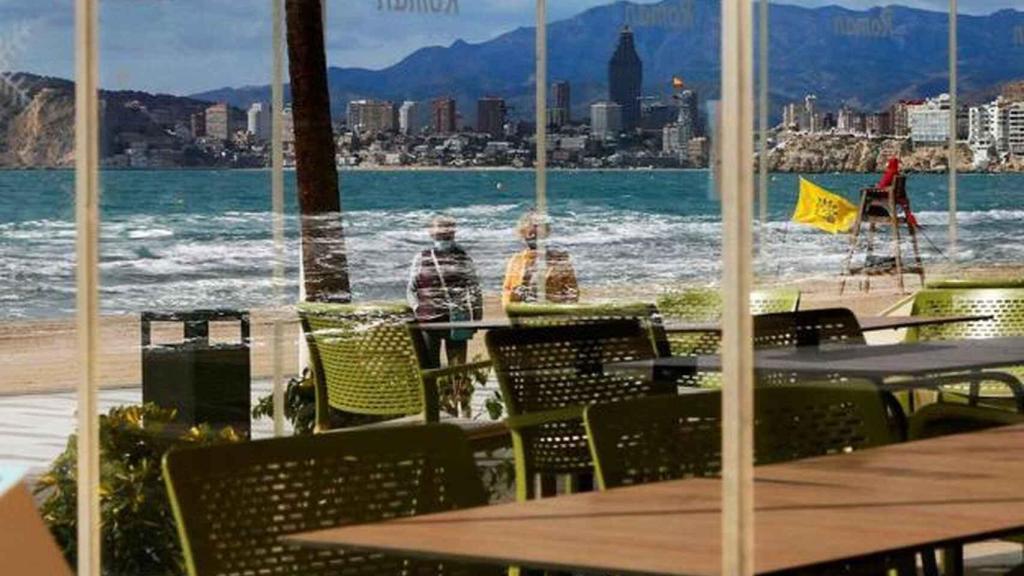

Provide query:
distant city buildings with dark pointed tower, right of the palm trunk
left=338, top=27, right=708, bottom=167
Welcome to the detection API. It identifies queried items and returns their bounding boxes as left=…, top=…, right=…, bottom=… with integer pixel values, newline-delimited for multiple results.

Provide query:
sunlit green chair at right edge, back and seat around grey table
left=906, top=288, right=1024, bottom=409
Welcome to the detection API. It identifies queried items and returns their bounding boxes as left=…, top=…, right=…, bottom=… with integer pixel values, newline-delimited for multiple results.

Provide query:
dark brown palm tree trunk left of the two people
left=285, top=0, right=351, bottom=302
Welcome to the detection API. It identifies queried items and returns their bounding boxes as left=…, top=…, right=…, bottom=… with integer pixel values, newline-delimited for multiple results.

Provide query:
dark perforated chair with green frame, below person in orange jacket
left=486, top=320, right=675, bottom=500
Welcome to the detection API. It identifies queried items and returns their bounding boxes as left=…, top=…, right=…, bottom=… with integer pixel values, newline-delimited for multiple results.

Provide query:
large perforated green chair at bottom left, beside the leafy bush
left=164, top=424, right=503, bottom=576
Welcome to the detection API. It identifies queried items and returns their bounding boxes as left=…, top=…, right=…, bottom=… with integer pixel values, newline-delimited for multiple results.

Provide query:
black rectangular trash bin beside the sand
left=142, top=310, right=251, bottom=437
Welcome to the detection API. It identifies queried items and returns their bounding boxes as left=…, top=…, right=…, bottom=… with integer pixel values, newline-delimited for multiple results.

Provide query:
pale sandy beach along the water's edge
left=0, top=266, right=1024, bottom=395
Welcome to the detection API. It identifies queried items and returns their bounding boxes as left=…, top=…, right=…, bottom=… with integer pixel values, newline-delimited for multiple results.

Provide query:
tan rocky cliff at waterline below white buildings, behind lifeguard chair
left=768, top=133, right=974, bottom=173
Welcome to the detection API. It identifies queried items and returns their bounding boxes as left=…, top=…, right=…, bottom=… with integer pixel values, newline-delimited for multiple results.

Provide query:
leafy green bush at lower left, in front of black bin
left=35, top=404, right=241, bottom=576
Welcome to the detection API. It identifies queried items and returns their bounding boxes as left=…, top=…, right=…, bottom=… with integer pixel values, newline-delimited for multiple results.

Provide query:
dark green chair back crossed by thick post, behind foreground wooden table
left=585, top=381, right=897, bottom=489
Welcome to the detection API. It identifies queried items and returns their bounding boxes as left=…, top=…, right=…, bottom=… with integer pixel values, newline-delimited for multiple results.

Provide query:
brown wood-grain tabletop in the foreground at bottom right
left=289, top=426, right=1024, bottom=576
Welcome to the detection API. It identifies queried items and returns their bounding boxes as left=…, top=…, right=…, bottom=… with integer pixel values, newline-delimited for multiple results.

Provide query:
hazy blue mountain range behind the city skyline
left=193, top=0, right=1024, bottom=123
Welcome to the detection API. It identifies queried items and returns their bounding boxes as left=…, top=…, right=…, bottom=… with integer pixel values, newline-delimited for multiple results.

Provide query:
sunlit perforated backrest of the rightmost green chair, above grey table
left=906, top=288, right=1024, bottom=341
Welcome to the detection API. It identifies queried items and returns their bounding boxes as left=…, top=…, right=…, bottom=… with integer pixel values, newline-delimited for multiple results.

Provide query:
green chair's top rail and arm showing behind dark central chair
left=505, top=302, right=671, bottom=357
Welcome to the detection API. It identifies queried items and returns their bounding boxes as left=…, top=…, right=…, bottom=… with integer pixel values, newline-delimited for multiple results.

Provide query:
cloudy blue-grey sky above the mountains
left=0, top=0, right=1021, bottom=94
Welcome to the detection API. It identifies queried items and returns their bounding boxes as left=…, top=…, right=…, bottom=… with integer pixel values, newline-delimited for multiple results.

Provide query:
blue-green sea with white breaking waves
left=0, top=170, right=1024, bottom=319
